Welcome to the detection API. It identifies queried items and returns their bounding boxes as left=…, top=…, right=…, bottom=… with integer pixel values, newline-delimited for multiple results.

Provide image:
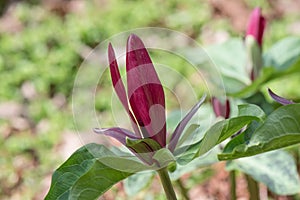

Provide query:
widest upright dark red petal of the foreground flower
left=126, top=34, right=166, bottom=147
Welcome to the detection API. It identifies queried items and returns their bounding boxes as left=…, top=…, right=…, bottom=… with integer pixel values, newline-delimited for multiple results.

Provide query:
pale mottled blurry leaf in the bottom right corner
left=227, top=150, right=300, bottom=195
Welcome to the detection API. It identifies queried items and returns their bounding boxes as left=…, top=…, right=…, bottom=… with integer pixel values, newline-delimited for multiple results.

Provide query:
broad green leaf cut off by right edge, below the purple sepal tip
left=218, top=104, right=300, bottom=160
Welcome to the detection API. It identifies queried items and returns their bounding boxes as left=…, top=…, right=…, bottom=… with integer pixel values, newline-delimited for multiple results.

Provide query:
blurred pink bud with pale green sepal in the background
left=245, top=8, right=266, bottom=81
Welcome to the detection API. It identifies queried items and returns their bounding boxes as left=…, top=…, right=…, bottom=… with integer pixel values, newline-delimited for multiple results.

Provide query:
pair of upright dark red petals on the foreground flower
left=108, top=34, right=166, bottom=147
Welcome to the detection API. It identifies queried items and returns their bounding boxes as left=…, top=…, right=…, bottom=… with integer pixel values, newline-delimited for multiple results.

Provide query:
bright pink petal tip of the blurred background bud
left=246, top=8, right=266, bottom=46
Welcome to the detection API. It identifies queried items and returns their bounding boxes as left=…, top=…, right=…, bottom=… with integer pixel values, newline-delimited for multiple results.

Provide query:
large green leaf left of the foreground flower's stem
left=45, top=144, right=149, bottom=200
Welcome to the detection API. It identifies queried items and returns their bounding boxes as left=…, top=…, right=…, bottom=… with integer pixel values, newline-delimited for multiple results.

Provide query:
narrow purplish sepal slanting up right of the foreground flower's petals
left=168, top=95, right=206, bottom=152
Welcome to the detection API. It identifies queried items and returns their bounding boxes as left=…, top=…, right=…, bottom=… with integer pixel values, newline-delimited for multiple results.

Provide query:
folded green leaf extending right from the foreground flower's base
left=175, top=116, right=259, bottom=164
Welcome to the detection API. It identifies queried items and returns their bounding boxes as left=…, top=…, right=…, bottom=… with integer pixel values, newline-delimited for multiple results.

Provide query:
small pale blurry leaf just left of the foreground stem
left=124, top=171, right=155, bottom=196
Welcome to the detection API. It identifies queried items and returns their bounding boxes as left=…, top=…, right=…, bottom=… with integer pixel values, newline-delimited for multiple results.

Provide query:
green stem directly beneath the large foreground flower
left=157, top=167, right=177, bottom=200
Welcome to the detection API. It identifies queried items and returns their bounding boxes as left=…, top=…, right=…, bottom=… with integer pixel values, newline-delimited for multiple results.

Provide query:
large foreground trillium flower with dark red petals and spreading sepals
left=94, top=34, right=205, bottom=165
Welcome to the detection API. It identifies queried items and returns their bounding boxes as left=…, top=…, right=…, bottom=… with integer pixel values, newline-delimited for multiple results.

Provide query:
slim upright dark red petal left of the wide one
left=108, top=43, right=141, bottom=136
